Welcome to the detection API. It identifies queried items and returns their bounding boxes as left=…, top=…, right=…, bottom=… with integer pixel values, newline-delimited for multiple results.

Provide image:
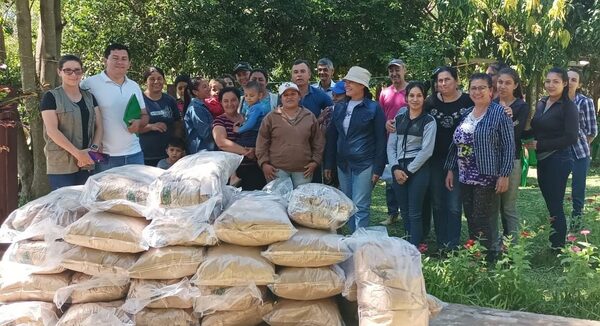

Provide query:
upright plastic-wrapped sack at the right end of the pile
left=354, top=237, right=429, bottom=326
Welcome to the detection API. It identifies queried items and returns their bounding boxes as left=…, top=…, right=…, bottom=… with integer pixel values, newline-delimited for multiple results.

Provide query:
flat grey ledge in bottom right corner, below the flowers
left=429, top=304, right=600, bottom=326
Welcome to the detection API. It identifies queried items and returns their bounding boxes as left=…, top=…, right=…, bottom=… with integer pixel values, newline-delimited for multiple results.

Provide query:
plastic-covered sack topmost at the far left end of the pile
left=0, top=186, right=87, bottom=243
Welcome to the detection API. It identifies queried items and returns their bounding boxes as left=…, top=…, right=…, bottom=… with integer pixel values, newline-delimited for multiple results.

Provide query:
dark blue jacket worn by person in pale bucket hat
left=325, top=98, right=386, bottom=176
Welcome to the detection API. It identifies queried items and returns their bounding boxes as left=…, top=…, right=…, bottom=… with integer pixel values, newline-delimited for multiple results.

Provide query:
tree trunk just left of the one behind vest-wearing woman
left=16, top=0, right=38, bottom=199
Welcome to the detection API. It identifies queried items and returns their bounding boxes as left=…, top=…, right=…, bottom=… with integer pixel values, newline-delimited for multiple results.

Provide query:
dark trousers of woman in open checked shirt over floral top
left=460, top=183, right=500, bottom=251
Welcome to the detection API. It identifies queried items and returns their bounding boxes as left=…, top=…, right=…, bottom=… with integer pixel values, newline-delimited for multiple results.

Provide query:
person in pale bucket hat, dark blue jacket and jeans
left=324, top=66, right=386, bottom=232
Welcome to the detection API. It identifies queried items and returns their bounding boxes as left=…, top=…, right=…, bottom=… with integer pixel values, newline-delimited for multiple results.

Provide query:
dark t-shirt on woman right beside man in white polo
left=140, top=93, right=181, bottom=160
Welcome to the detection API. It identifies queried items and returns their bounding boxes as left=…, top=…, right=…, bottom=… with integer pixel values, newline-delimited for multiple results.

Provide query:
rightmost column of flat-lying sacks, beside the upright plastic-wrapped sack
left=262, top=184, right=356, bottom=326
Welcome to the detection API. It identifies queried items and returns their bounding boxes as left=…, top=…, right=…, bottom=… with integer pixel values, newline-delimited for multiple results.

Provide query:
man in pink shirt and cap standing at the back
left=379, top=59, right=406, bottom=225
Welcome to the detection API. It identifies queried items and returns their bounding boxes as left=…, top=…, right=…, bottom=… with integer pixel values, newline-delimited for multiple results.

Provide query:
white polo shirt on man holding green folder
left=81, top=71, right=146, bottom=156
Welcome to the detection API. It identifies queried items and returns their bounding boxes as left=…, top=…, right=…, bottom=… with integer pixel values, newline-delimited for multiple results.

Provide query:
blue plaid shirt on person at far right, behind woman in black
left=572, top=93, right=598, bottom=159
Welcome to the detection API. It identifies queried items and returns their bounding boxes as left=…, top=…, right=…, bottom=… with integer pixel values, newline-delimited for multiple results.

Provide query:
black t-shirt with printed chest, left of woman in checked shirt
left=423, top=93, right=474, bottom=159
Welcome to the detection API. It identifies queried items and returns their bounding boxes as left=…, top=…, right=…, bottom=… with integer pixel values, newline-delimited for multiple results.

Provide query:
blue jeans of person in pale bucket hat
left=338, top=166, right=373, bottom=233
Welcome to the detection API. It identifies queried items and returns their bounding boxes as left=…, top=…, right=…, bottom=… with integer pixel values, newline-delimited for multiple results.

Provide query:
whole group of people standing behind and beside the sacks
left=41, top=44, right=597, bottom=255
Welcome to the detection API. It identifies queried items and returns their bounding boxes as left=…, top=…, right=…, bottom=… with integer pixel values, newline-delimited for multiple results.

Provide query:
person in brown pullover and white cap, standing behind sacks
left=256, top=82, right=325, bottom=188
